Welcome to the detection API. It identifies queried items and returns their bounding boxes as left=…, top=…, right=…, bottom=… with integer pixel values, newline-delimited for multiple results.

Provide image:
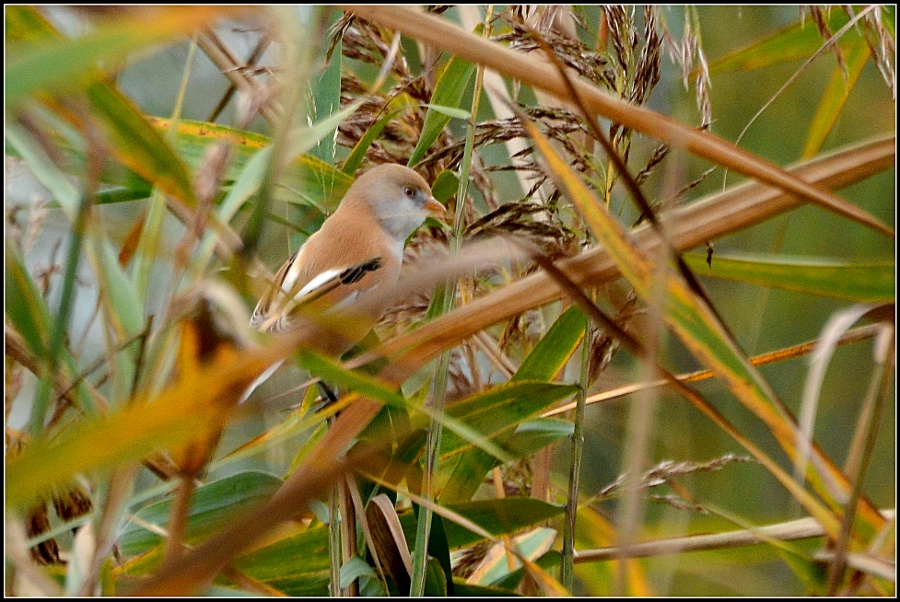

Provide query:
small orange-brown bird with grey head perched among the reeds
left=250, top=164, right=445, bottom=352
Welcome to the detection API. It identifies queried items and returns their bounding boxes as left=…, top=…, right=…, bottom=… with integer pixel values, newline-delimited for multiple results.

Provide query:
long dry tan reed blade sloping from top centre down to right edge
left=341, top=5, right=894, bottom=237
